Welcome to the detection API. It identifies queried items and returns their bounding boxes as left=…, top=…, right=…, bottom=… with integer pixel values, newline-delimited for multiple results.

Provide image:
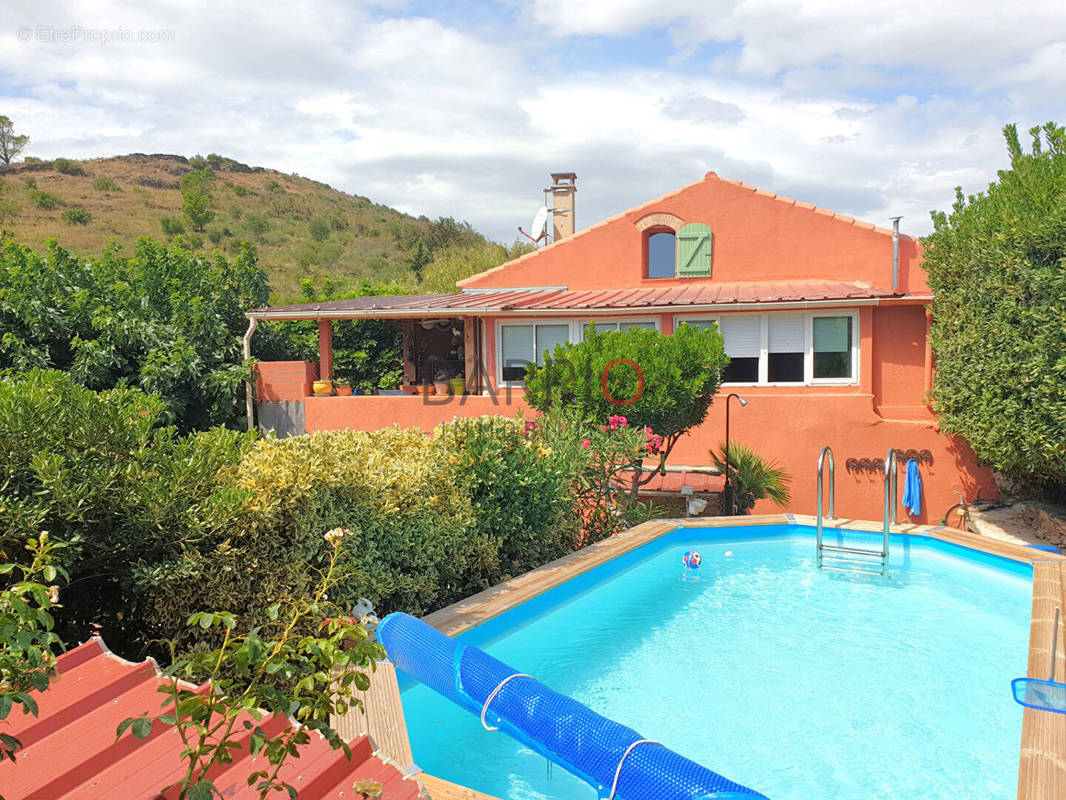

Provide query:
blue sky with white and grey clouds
left=0, top=0, right=1066, bottom=241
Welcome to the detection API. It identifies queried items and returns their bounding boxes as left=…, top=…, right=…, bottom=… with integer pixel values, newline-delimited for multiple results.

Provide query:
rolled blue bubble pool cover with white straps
left=377, top=613, right=765, bottom=800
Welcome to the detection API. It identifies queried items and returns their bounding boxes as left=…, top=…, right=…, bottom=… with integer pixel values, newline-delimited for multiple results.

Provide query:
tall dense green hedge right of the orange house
left=924, top=123, right=1066, bottom=490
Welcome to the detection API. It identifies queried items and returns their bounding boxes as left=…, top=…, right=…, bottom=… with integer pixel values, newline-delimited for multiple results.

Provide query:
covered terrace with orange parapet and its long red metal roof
left=244, top=281, right=909, bottom=435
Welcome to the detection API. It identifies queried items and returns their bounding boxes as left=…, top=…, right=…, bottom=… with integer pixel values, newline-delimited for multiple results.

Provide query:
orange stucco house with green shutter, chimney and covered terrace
left=246, top=173, right=995, bottom=523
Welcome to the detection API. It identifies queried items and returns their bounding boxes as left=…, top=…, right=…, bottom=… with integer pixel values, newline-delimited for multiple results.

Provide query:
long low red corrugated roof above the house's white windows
left=248, top=281, right=905, bottom=319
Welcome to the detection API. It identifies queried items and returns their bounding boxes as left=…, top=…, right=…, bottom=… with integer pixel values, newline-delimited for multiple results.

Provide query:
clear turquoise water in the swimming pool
left=403, top=526, right=1032, bottom=800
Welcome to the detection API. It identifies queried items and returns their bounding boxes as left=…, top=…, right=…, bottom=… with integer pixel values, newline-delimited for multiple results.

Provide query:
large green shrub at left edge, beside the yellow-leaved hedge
left=0, top=370, right=252, bottom=657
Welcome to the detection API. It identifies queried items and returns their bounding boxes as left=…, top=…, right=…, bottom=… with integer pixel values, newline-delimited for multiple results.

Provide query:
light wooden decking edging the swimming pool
left=423, top=514, right=1066, bottom=800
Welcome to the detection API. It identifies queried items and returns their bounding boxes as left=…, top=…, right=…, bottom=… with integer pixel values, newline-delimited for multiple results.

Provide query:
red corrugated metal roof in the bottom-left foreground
left=0, top=639, right=420, bottom=800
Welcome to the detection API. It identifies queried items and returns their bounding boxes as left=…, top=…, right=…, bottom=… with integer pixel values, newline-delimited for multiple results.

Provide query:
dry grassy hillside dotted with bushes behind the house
left=0, top=154, right=492, bottom=302
